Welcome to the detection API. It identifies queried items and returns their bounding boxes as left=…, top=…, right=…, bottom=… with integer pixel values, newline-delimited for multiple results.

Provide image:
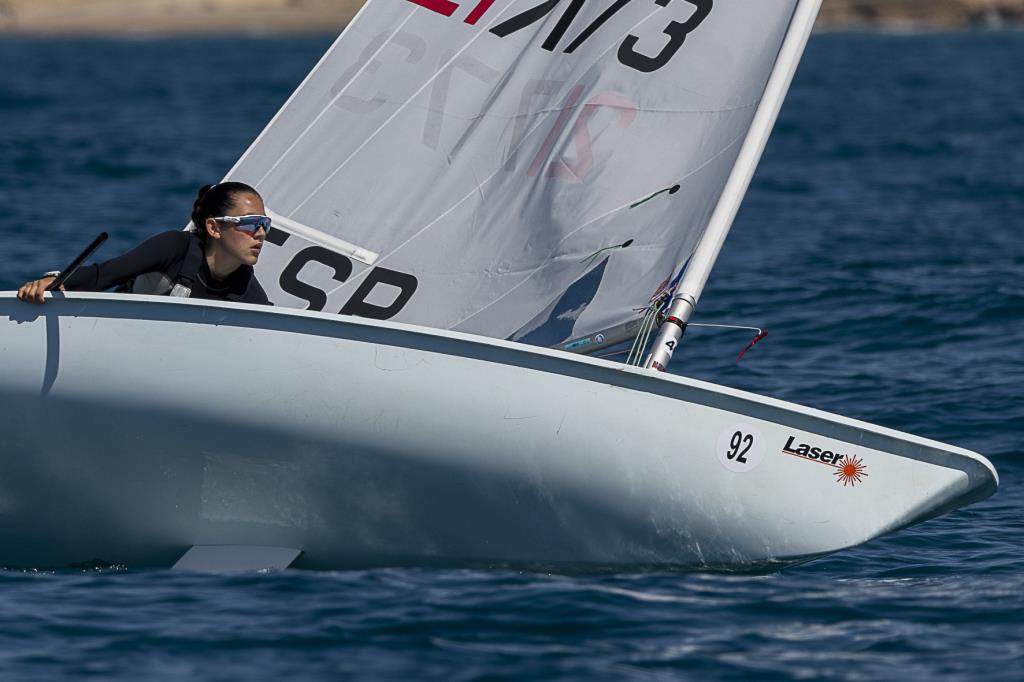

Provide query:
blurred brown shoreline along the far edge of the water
left=0, top=0, right=1024, bottom=35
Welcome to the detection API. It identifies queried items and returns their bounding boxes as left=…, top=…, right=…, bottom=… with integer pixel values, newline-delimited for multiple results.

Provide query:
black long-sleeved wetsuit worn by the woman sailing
left=65, top=230, right=270, bottom=305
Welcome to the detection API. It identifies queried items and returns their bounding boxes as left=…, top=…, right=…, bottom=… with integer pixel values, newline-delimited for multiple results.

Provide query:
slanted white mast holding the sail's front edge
left=644, top=0, right=821, bottom=372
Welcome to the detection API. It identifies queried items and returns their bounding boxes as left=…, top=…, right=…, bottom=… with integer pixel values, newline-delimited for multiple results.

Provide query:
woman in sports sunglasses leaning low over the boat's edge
left=17, top=182, right=270, bottom=305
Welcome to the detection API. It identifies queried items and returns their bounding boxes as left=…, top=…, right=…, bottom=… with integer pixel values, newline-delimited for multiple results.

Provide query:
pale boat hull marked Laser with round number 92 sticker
left=0, top=293, right=997, bottom=568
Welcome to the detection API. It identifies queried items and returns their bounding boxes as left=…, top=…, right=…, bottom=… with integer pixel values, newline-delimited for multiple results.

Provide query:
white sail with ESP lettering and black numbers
left=228, top=0, right=801, bottom=343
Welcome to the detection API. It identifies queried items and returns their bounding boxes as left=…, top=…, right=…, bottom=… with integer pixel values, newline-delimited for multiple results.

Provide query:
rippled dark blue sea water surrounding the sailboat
left=0, top=32, right=1024, bottom=680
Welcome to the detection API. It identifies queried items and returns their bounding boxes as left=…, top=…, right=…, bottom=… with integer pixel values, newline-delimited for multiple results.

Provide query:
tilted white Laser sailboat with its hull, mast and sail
left=0, top=0, right=998, bottom=570
